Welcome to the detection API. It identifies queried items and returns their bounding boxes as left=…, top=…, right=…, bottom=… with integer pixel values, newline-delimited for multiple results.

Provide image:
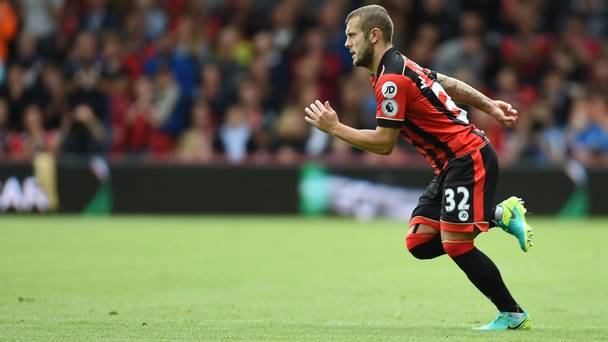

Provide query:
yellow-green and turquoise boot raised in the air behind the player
left=494, top=196, right=534, bottom=252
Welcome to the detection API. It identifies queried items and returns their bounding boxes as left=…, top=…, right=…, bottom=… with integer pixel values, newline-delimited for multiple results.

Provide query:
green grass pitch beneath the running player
left=0, top=216, right=608, bottom=341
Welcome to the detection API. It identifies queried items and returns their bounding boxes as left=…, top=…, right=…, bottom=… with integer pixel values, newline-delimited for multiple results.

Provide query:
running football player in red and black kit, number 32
left=304, top=5, right=532, bottom=330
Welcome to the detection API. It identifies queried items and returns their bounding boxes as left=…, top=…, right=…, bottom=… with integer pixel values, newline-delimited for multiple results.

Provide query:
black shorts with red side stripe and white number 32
left=410, top=144, right=498, bottom=232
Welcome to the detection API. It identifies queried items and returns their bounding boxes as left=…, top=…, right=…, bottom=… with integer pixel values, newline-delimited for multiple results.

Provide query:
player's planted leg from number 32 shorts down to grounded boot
left=440, top=145, right=530, bottom=329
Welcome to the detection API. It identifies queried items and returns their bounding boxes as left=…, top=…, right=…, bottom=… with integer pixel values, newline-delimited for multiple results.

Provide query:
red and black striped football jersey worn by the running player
left=372, top=48, right=488, bottom=174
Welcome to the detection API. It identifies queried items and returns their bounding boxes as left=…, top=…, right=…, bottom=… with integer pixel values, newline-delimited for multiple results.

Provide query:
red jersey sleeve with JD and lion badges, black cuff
left=374, top=74, right=410, bottom=128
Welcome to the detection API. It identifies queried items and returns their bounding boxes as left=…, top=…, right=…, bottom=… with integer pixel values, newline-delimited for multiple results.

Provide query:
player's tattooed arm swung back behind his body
left=437, top=73, right=518, bottom=127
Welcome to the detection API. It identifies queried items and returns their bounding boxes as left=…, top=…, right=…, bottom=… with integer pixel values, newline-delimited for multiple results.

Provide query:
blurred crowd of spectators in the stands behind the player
left=0, top=0, right=608, bottom=167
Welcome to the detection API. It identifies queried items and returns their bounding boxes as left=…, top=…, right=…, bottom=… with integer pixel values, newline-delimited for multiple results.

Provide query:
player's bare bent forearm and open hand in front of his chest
left=304, top=100, right=400, bottom=155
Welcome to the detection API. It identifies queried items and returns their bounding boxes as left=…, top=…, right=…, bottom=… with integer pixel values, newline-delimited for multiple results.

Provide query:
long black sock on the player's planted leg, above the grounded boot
left=452, top=248, right=523, bottom=312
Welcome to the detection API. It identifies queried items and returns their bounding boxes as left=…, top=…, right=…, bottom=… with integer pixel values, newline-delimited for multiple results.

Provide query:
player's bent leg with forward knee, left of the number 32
left=405, top=176, right=445, bottom=259
